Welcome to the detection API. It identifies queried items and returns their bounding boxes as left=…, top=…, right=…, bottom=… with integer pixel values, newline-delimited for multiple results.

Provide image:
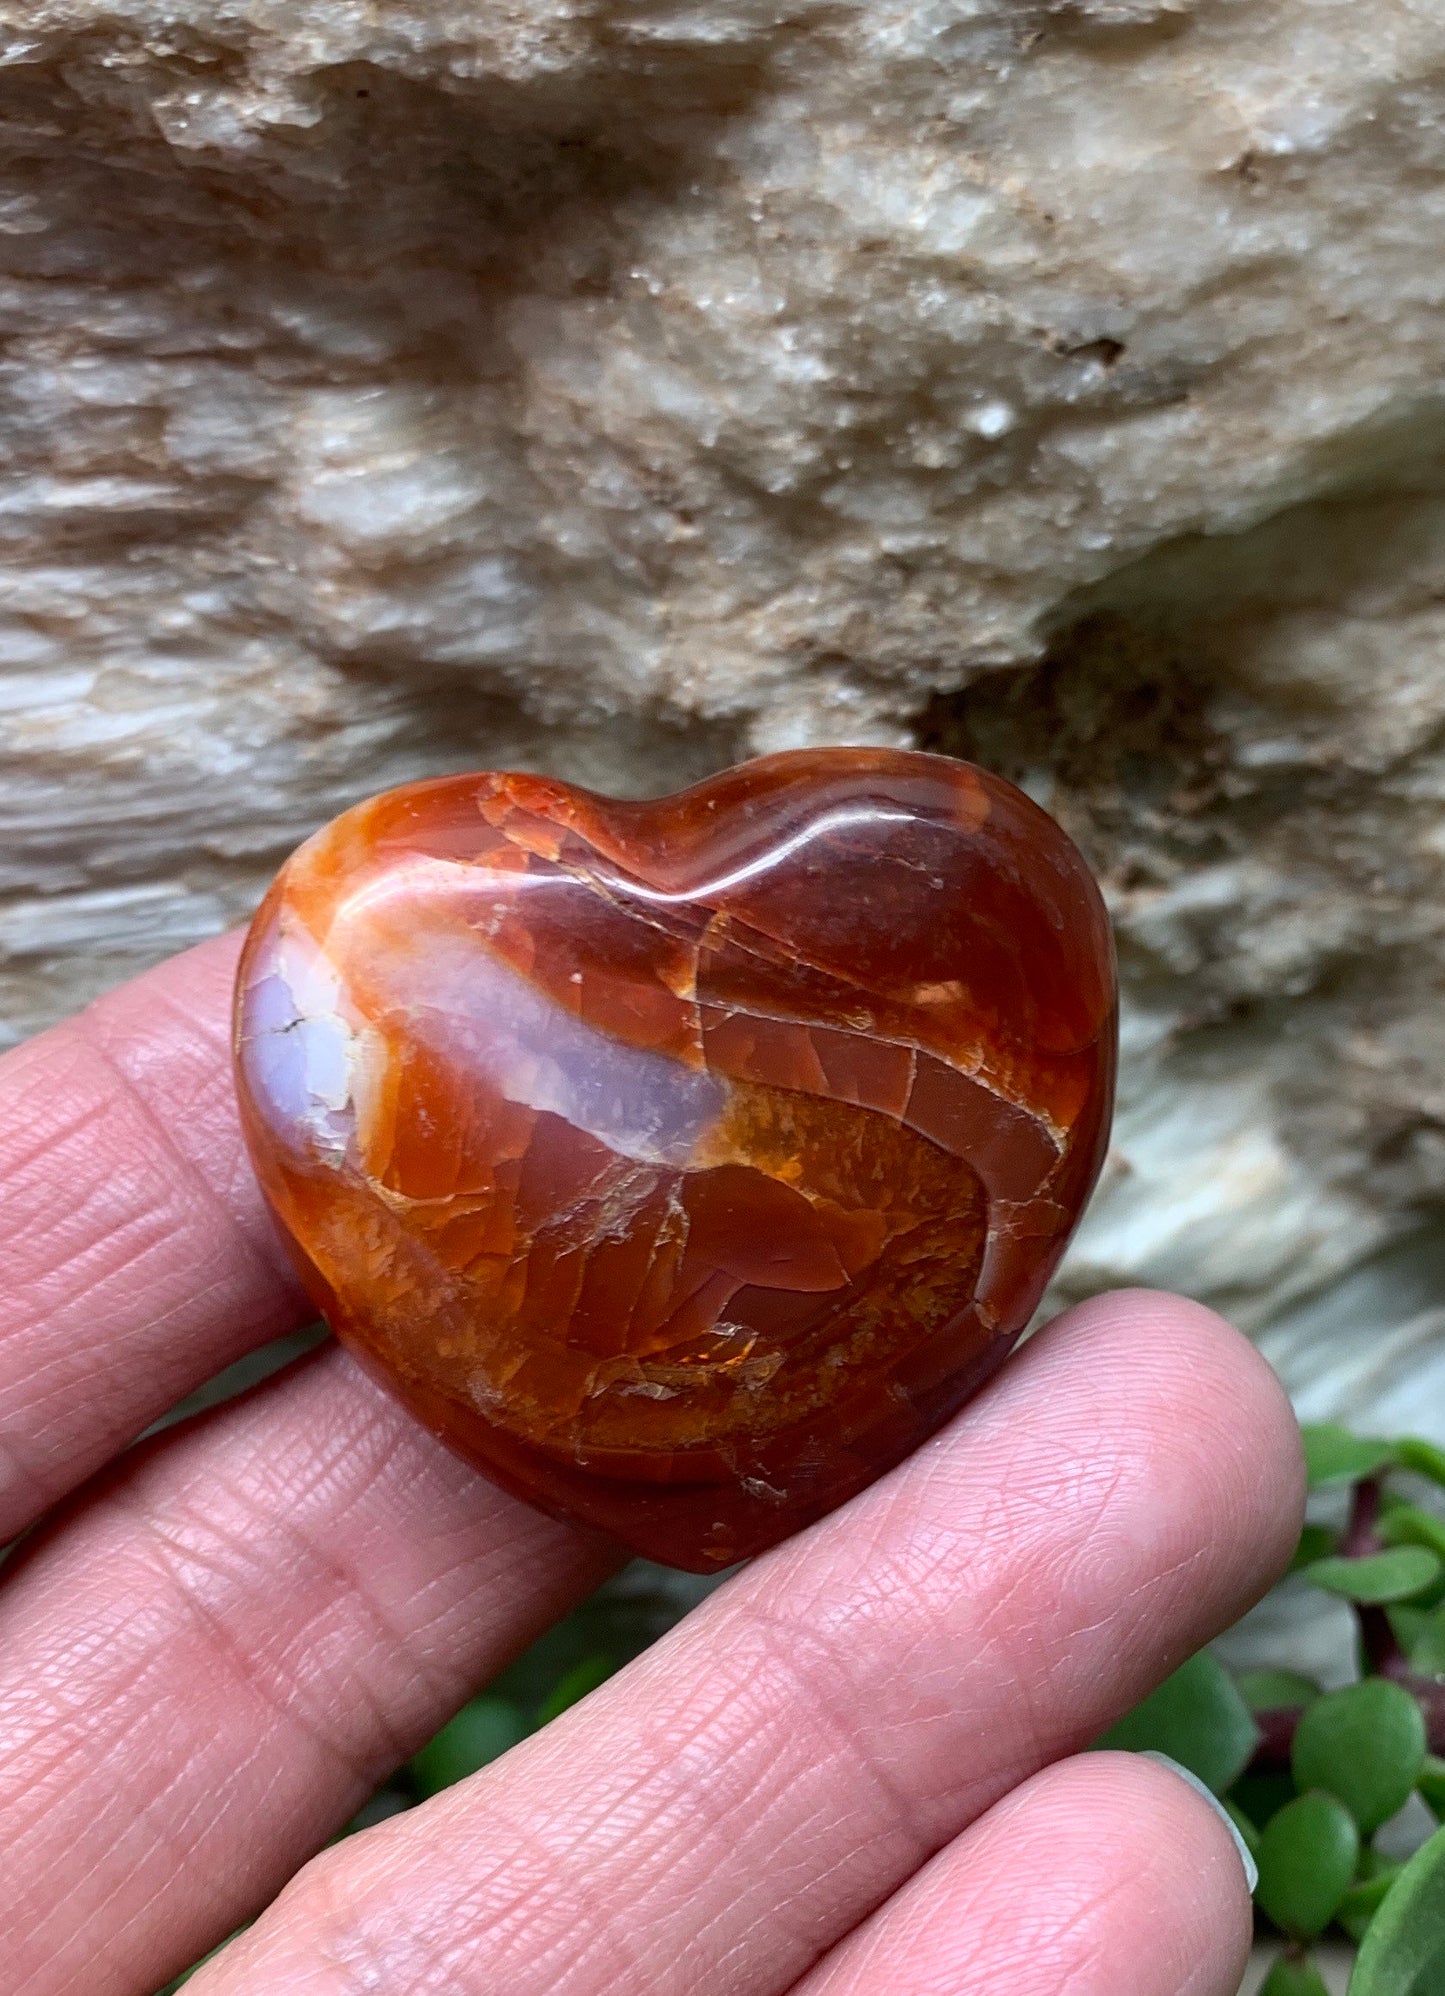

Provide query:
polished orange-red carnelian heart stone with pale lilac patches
left=236, top=749, right=1116, bottom=1573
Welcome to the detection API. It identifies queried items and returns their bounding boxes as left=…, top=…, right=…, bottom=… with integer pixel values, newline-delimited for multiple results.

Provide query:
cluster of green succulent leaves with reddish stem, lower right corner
left=1106, top=1425, right=1445, bottom=1972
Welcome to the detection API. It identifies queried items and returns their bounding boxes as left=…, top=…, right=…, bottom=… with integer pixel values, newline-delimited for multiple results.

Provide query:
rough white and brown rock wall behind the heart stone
left=0, top=0, right=1445, bottom=1437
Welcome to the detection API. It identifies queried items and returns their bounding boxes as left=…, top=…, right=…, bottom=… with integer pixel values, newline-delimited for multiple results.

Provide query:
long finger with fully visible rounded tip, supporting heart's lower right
left=186, top=1293, right=1303, bottom=1996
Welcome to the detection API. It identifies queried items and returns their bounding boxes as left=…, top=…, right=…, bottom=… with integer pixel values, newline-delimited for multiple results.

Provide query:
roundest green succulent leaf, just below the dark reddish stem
left=1289, top=1677, right=1425, bottom=1836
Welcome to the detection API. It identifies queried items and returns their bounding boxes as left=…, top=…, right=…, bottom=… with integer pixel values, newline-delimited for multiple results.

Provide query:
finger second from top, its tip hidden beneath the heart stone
left=0, top=1347, right=617, bottom=1996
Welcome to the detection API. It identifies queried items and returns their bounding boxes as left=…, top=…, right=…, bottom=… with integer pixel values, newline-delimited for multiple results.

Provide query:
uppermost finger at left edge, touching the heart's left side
left=0, top=936, right=313, bottom=1543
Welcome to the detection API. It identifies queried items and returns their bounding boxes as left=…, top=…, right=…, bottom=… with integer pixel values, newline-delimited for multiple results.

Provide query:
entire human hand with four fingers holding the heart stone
left=0, top=940, right=1303, bottom=1996
